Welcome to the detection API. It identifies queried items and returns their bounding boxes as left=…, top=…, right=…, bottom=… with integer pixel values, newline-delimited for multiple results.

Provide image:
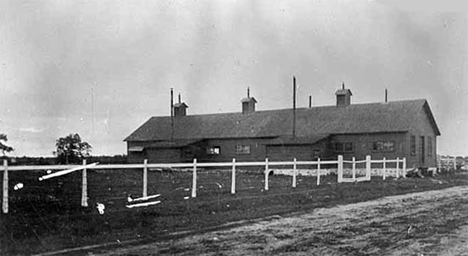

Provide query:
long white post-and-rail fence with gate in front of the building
left=2, top=155, right=406, bottom=213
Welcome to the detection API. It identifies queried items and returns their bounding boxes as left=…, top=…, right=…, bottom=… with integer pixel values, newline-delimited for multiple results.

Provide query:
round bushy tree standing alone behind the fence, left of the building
left=54, top=133, right=92, bottom=164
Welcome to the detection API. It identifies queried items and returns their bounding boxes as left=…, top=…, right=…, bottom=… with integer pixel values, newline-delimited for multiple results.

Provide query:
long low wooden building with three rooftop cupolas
left=124, top=86, right=440, bottom=167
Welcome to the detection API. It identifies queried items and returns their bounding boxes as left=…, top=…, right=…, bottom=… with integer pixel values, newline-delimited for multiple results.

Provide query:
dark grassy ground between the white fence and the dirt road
left=0, top=169, right=468, bottom=255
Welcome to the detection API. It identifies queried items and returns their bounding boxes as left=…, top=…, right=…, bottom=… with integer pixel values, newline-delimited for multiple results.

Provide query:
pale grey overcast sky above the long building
left=0, top=0, right=468, bottom=156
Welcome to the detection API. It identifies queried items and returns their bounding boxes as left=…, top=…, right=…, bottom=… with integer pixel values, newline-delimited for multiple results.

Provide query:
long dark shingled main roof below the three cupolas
left=125, top=100, right=440, bottom=141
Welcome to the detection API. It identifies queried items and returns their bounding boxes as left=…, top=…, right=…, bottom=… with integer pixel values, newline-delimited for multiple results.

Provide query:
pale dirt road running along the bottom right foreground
left=92, top=186, right=468, bottom=255
